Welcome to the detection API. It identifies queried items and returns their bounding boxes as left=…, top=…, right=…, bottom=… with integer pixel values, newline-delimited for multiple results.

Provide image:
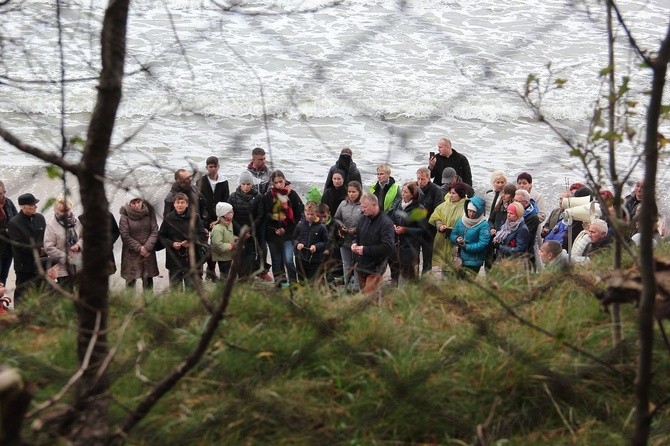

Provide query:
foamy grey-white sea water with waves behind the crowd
left=0, top=0, right=670, bottom=216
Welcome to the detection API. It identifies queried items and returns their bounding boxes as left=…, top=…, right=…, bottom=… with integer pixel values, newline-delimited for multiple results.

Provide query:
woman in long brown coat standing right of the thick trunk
left=119, top=194, right=158, bottom=291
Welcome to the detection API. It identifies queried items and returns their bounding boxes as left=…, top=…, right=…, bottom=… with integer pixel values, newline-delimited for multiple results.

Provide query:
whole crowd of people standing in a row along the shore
left=0, top=138, right=660, bottom=305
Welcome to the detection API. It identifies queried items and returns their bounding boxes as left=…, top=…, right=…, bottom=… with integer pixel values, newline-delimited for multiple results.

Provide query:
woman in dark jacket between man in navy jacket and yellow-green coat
left=389, top=181, right=427, bottom=285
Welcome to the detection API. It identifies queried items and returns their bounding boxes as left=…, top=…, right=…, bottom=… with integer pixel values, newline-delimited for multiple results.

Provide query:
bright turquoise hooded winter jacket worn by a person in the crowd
left=451, top=197, right=491, bottom=268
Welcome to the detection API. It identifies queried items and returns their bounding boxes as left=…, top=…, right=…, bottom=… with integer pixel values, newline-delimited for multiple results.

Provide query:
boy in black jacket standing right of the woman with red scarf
left=293, top=201, right=328, bottom=281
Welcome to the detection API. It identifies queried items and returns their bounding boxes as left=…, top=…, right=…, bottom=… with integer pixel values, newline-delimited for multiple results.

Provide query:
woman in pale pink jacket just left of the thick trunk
left=44, top=196, right=84, bottom=291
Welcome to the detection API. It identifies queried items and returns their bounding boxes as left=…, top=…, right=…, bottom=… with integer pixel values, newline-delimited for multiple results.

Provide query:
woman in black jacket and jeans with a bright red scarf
left=256, top=170, right=303, bottom=286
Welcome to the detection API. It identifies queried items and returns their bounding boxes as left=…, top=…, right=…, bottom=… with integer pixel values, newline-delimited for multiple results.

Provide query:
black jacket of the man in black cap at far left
left=7, top=212, right=47, bottom=274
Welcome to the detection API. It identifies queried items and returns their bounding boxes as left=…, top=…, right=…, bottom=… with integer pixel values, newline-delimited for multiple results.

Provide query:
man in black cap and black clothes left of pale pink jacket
left=7, top=193, right=47, bottom=307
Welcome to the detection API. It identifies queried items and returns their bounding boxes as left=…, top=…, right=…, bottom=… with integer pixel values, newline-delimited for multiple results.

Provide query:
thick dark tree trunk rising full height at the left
left=72, top=0, right=130, bottom=445
